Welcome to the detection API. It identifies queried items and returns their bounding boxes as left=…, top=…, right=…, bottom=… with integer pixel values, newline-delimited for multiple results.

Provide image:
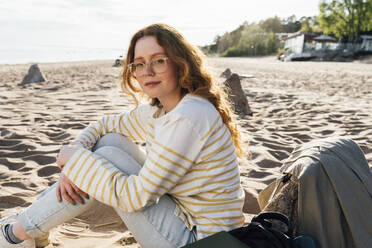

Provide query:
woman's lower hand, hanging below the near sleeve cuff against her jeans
left=56, top=173, right=89, bottom=205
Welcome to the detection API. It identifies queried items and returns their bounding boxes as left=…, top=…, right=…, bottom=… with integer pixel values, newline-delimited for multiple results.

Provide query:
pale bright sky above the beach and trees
left=0, top=0, right=319, bottom=56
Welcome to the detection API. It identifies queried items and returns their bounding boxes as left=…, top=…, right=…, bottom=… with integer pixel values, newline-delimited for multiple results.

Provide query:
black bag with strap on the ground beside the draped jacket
left=229, top=212, right=315, bottom=248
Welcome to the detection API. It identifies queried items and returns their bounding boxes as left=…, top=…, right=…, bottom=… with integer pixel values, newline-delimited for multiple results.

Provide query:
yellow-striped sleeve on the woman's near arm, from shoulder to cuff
left=63, top=117, right=205, bottom=212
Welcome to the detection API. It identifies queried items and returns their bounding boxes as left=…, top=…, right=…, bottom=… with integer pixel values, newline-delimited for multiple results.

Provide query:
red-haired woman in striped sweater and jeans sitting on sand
left=0, top=24, right=248, bottom=247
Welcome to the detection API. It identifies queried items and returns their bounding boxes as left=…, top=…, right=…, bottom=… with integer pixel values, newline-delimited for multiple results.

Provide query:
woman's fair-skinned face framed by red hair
left=133, top=36, right=181, bottom=105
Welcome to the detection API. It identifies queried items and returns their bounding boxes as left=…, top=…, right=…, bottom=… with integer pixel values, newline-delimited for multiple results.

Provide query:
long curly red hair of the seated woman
left=121, top=23, right=246, bottom=158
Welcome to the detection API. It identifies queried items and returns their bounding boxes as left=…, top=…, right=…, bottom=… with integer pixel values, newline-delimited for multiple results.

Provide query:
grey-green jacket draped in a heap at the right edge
left=259, top=138, right=372, bottom=248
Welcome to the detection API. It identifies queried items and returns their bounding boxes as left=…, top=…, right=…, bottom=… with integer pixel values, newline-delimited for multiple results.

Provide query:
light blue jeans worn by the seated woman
left=18, top=134, right=196, bottom=248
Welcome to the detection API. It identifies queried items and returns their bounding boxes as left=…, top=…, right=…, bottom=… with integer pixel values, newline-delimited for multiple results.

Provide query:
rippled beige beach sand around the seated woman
left=0, top=57, right=372, bottom=248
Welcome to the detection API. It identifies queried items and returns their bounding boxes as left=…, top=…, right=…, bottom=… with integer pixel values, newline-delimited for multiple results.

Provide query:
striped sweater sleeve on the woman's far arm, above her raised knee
left=75, top=105, right=150, bottom=150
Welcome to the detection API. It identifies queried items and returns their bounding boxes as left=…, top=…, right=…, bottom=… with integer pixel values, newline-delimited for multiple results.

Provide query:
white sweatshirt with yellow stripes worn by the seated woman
left=63, top=94, right=244, bottom=239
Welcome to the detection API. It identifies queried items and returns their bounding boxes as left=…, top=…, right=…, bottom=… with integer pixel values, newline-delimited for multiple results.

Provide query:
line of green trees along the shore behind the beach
left=202, top=0, right=372, bottom=57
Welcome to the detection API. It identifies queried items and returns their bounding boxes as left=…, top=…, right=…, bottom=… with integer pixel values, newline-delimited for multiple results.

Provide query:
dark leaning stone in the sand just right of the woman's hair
left=224, top=73, right=253, bottom=117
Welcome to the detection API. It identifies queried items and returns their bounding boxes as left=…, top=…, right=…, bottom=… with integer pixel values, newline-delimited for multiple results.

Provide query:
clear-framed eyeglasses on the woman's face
left=128, top=57, right=169, bottom=77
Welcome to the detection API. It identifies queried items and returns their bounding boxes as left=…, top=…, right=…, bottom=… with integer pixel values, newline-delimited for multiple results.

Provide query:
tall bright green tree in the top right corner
left=318, top=0, right=372, bottom=42
